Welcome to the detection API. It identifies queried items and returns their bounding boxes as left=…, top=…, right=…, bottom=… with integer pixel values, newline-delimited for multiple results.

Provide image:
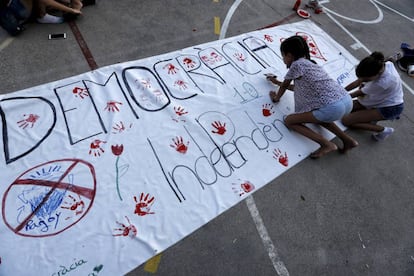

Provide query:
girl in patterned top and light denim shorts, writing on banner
left=267, top=36, right=358, bottom=158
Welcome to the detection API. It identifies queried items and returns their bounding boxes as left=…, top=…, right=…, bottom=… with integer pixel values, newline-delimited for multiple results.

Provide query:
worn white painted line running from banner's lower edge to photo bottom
left=246, top=196, right=289, bottom=276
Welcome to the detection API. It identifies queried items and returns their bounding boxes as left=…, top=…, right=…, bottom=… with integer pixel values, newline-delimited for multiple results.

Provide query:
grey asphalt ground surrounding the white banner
left=0, top=0, right=414, bottom=276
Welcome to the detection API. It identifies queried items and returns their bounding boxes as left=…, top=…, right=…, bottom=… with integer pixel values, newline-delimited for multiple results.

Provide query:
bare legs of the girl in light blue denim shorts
left=285, top=112, right=358, bottom=158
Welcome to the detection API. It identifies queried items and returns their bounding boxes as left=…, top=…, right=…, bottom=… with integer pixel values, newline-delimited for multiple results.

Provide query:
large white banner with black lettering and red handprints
left=0, top=21, right=357, bottom=276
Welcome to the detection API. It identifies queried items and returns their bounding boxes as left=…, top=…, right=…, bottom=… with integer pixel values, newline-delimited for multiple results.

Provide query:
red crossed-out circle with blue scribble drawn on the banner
left=2, top=159, right=96, bottom=237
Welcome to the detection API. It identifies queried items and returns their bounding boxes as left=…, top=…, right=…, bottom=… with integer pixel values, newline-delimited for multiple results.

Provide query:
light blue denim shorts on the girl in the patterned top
left=312, top=95, right=352, bottom=123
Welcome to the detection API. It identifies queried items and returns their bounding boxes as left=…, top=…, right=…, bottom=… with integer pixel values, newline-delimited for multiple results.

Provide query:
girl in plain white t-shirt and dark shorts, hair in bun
left=342, top=52, right=404, bottom=141
